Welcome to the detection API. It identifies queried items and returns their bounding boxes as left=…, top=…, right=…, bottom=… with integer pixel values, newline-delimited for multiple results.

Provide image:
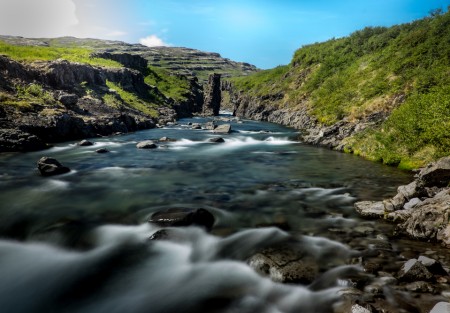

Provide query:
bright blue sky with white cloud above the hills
left=0, top=0, right=450, bottom=69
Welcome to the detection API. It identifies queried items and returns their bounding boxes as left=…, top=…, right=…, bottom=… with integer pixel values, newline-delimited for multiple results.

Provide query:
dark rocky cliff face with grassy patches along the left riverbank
left=0, top=56, right=175, bottom=152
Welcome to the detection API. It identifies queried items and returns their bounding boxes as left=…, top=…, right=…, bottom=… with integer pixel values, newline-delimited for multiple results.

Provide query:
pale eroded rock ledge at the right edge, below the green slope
left=355, top=157, right=450, bottom=247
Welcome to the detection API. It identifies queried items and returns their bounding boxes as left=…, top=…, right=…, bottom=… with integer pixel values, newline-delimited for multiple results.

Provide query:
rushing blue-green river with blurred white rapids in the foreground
left=0, top=114, right=442, bottom=313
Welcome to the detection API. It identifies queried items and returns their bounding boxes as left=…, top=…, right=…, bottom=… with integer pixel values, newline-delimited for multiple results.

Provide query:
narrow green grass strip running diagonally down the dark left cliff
left=103, top=81, right=159, bottom=117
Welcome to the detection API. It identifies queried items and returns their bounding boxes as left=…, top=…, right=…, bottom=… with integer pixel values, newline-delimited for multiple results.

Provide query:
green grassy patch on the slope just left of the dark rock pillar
left=145, top=66, right=190, bottom=101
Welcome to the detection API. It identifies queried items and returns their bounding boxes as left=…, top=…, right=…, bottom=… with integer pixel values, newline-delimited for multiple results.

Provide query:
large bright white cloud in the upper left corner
left=0, top=0, right=78, bottom=37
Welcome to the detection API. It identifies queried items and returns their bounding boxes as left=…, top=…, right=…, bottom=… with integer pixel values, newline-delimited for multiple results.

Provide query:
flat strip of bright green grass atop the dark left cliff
left=0, top=41, right=122, bottom=67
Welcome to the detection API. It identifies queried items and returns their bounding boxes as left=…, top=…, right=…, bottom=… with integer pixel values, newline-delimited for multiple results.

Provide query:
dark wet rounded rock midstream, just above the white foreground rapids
left=149, top=208, right=215, bottom=230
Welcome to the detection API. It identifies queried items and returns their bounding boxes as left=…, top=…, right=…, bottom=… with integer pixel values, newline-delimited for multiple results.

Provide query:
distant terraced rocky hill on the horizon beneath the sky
left=0, top=36, right=258, bottom=82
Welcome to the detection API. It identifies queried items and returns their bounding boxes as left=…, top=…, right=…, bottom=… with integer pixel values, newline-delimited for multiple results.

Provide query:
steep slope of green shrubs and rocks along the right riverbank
left=230, top=12, right=450, bottom=168
